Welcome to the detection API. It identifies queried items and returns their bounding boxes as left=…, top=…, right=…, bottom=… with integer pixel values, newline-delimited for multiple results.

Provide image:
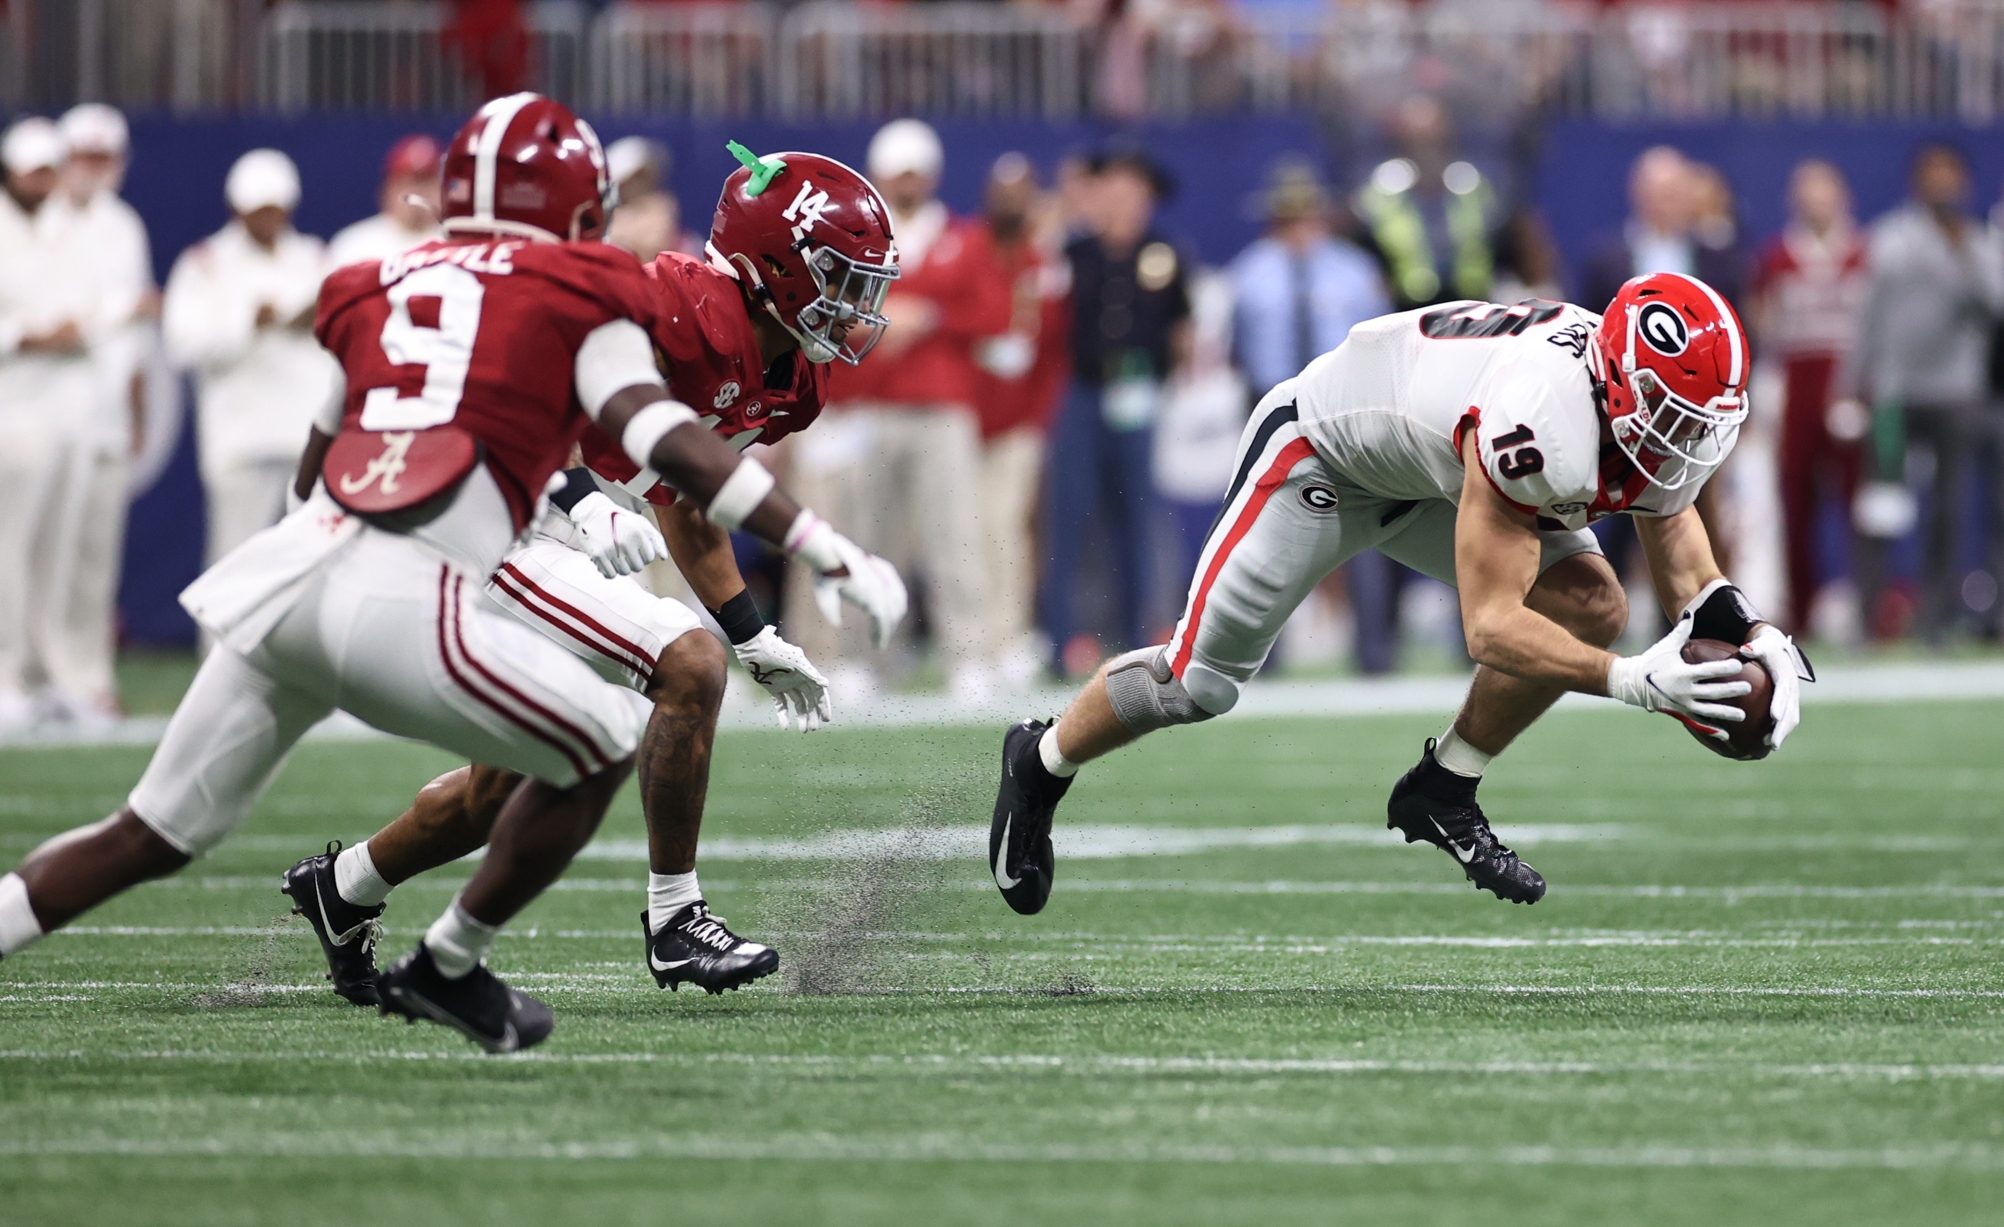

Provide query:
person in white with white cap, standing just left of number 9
left=160, top=148, right=339, bottom=563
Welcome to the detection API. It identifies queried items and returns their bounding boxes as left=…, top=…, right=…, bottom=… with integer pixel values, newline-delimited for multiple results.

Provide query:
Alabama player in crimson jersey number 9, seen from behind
left=0, top=94, right=904, bottom=1051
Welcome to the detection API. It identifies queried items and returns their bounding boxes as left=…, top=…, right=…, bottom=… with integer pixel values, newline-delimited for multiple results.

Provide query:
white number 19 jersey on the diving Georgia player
left=1295, top=299, right=1699, bottom=529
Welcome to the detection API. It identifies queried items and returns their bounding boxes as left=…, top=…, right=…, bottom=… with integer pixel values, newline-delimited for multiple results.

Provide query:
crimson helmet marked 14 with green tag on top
left=703, top=142, right=898, bottom=365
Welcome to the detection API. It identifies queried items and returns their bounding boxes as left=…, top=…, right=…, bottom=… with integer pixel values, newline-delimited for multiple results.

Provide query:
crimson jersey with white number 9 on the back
left=313, top=239, right=657, bottom=531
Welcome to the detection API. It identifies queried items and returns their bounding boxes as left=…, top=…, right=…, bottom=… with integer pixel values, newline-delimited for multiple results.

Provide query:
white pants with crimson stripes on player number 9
left=130, top=527, right=651, bottom=856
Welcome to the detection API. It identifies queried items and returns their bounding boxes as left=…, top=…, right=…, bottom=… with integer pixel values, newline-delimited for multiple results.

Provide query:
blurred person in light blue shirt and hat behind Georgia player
left=1230, top=162, right=1399, bottom=674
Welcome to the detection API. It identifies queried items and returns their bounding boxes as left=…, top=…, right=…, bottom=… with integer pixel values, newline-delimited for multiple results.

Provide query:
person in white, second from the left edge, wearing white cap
left=42, top=102, right=160, bottom=724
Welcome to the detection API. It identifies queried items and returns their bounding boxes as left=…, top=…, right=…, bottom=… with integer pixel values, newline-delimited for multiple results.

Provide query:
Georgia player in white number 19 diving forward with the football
left=988, top=273, right=1814, bottom=914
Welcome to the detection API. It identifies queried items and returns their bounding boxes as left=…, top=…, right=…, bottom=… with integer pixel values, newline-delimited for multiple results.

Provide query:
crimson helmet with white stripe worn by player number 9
left=439, top=94, right=611, bottom=243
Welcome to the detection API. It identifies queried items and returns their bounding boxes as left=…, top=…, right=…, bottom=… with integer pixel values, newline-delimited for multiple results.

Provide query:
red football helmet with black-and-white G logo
left=1589, top=273, right=1751, bottom=489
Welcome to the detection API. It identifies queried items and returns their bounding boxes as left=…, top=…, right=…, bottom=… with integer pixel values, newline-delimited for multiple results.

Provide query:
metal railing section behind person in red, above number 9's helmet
left=259, top=0, right=589, bottom=110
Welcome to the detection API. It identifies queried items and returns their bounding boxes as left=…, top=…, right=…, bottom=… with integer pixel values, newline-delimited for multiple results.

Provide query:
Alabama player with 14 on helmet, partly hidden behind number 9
left=287, top=144, right=898, bottom=1004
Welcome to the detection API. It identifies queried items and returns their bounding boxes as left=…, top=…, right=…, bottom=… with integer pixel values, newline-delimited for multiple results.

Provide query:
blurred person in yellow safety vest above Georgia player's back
left=1357, top=94, right=1499, bottom=311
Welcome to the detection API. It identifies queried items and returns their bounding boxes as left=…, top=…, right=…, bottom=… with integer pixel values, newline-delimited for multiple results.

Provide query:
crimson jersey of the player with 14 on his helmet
left=583, top=251, right=828, bottom=507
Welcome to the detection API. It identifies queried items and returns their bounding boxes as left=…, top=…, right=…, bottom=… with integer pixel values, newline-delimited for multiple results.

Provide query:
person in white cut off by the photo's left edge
left=0, top=116, right=100, bottom=732
